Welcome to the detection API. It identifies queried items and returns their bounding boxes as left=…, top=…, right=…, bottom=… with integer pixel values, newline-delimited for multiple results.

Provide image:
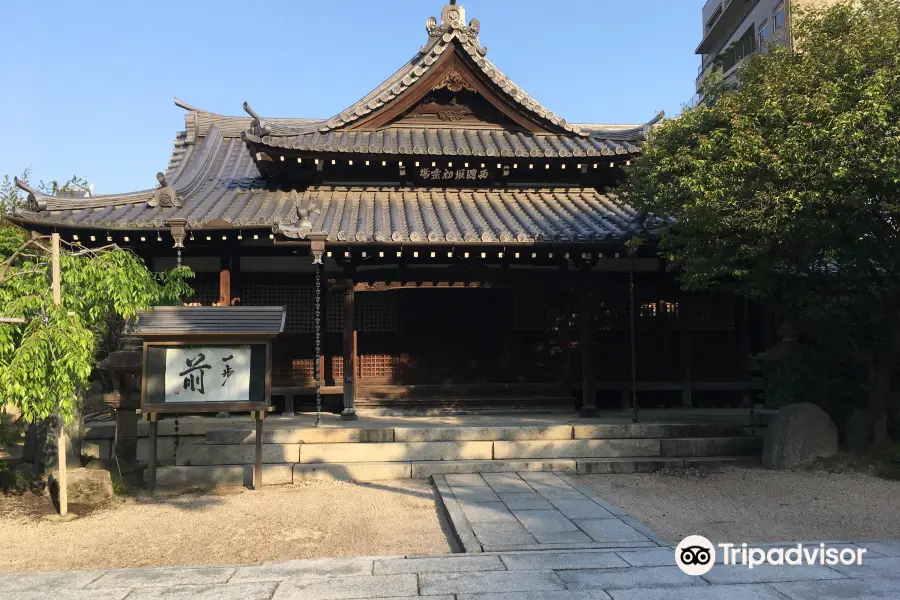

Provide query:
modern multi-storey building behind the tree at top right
left=697, top=0, right=829, bottom=101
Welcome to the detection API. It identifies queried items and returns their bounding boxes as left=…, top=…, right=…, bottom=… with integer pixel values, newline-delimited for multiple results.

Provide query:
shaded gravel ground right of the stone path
left=577, top=468, right=900, bottom=543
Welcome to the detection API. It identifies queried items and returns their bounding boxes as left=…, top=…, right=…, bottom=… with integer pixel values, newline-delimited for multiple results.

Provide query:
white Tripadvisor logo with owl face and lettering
left=675, top=535, right=866, bottom=576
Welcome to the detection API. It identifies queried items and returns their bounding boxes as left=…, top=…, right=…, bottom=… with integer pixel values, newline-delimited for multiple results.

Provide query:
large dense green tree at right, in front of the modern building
left=626, top=0, right=900, bottom=442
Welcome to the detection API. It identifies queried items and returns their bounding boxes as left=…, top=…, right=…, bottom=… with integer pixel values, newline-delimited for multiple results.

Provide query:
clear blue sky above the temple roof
left=0, top=0, right=703, bottom=194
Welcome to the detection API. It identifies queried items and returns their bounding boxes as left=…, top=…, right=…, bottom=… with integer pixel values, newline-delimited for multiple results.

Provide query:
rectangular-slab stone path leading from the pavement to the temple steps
left=434, top=472, right=671, bottom=552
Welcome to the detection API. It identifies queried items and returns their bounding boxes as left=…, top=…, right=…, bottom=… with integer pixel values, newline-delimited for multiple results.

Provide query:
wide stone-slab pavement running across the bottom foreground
left=0, top=540, right=900, bottom=600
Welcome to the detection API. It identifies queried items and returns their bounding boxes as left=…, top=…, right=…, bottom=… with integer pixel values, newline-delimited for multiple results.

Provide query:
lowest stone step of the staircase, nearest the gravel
left=156, top=456, right=760, bottom=489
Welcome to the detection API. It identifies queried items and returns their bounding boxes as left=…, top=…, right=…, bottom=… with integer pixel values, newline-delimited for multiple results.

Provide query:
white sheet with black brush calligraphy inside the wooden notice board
left=165, top=346, right=250, bottom=402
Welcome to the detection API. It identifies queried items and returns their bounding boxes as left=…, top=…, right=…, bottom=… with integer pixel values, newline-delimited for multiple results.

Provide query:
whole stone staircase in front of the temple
left=151, top=423, right=762, bottom=487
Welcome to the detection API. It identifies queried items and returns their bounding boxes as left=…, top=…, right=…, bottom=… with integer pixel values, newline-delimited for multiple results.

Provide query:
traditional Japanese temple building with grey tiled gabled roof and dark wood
left=8, top=2, right=770, bottom=419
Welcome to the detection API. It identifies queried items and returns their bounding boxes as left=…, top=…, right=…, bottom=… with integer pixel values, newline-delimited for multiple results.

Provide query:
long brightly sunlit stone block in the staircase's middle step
left=300, top=442, right=493, bottom=463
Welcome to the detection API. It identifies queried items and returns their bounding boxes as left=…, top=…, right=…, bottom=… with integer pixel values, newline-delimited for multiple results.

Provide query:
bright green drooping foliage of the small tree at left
left=0, top=216, right=193, bottom=422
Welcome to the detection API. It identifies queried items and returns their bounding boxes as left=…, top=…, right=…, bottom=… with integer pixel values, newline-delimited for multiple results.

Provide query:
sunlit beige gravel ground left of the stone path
left=0, top=480, right=450, bottom=571
